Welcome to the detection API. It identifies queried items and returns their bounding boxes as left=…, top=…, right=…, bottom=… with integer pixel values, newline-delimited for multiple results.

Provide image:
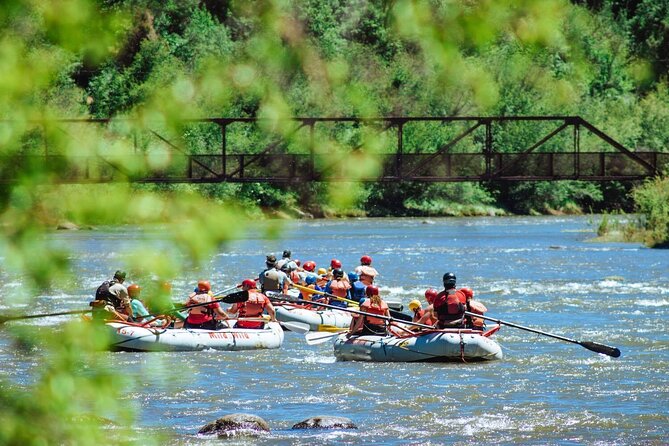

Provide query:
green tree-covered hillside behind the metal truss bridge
left=3, top=0, right=669, bottom=216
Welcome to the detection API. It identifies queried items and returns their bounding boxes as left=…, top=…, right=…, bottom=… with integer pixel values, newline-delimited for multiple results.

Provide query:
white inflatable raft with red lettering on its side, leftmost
left=106, top=320, right=283, bottom=352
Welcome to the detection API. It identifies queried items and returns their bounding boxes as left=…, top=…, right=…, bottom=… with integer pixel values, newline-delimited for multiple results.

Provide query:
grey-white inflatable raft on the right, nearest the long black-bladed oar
left=334, top=326, right=503, bottom=362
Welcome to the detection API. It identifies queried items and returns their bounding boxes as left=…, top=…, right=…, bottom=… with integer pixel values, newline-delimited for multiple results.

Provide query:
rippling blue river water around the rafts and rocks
left=0, top=217, right=669, bottom=445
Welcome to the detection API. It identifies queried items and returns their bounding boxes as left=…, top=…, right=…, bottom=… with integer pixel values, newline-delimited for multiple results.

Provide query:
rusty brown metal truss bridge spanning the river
left=0, top=116, right=669, bottom=184
